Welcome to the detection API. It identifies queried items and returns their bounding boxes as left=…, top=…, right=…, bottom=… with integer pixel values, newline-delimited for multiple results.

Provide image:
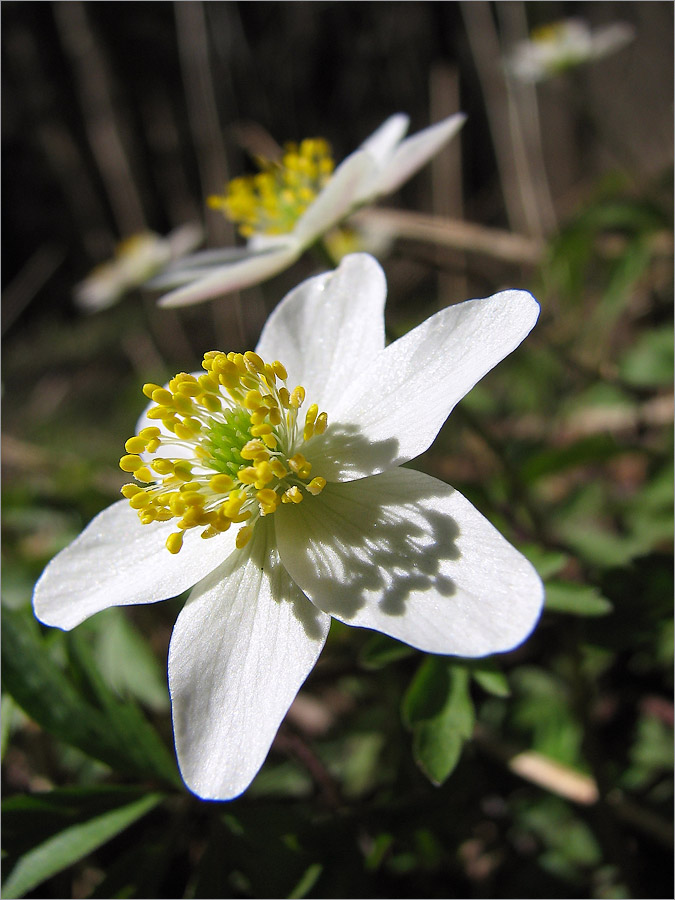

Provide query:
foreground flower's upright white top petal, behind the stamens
left=257, top=253, right=387, bottom=410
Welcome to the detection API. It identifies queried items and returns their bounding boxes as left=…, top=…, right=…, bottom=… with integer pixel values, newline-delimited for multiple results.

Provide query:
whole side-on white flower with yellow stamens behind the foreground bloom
left=153, top=113, right=466, bottom=306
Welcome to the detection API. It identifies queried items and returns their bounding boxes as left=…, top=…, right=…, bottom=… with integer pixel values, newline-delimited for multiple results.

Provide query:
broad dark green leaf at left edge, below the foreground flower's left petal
left=2, top=609, right=181, bottom=786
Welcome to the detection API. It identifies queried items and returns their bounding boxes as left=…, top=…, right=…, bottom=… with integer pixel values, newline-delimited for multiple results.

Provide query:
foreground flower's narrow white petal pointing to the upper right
left=305, top=291, right=539, bottom=481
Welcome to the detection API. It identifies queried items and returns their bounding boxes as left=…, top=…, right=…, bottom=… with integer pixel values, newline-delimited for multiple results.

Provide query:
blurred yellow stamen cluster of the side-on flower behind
left=208, top=138, right=334, bottom=238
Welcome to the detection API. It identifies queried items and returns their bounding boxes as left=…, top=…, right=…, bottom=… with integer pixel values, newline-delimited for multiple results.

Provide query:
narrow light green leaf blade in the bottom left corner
left=2, top=794, right=164, bottom=900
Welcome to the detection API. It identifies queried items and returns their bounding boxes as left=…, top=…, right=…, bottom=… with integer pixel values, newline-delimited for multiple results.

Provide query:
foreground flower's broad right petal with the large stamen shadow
left=275, top=469, right=543, bottom=656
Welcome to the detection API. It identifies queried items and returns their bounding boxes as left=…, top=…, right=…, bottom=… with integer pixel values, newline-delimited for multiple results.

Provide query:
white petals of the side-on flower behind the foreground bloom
left=153, top=113, right=466, bottom=306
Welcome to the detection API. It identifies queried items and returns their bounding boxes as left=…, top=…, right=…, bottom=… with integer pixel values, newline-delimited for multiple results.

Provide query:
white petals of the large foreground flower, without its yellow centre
left=34, top=255, right=543, bottom=800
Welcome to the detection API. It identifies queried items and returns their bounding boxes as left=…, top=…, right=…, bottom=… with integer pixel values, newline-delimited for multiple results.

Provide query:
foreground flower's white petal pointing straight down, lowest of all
left=169, top=522, right=330, bottom=800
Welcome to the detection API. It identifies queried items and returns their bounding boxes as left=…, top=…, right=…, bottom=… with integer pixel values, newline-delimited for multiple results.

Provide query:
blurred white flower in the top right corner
left=507, top=19, right=635, bottom=82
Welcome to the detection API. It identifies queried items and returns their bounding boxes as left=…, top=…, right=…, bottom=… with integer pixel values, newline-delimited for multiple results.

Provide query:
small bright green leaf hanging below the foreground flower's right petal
left=402, top=656, right=475, bottom=785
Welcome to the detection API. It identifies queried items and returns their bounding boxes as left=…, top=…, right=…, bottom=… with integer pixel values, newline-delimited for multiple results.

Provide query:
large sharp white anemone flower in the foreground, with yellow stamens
left=33, top=254, right=543, bottom=800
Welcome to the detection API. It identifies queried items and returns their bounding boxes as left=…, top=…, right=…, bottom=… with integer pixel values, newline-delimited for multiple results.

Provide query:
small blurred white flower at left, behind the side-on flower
left=75, top=224, right=203, bottom=312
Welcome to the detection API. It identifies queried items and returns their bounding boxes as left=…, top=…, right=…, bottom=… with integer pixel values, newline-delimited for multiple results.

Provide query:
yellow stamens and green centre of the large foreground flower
left=120, top=350, right=328, bottom=553
